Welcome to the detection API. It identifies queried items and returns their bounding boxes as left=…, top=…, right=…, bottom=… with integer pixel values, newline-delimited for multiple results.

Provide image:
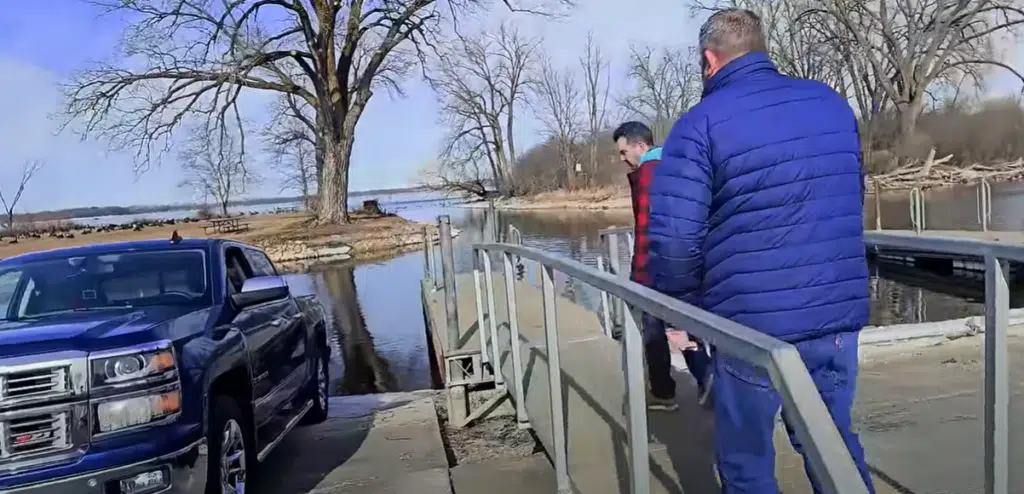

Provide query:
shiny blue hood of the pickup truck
left=0, top=305, right=211, bottom=358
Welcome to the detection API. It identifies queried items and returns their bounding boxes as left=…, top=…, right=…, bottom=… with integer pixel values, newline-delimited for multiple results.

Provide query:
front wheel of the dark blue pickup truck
left=206, top=396, right=256, bottom=494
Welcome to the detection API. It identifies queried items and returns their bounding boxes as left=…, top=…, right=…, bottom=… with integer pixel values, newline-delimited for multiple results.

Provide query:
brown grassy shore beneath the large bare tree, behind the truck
left=0, top=213, right=436, bottom=262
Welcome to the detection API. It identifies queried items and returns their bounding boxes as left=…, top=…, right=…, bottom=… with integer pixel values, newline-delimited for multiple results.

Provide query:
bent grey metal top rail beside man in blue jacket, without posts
left=472, top=243, right=867, bottom=494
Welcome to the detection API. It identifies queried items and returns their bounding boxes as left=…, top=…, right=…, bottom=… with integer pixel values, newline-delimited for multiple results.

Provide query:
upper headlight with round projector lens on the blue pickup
left=91, top=341, right=177, bottom=387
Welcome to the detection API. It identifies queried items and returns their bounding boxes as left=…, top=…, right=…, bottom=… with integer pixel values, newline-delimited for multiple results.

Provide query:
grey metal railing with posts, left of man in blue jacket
left=473, top=244, right=867, bottom=494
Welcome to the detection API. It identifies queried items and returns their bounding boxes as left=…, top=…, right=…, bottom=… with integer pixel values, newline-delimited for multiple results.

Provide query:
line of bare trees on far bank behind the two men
left=422, top=0, right=1024, bottom=196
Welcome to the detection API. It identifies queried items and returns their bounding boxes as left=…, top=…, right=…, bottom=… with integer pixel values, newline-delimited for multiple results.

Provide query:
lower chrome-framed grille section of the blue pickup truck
left=0, top=411, right=74, bottom=460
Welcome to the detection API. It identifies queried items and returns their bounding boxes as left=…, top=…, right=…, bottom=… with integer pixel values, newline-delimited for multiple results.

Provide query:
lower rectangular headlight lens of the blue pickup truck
left=95, top=386, right=181, bottom=434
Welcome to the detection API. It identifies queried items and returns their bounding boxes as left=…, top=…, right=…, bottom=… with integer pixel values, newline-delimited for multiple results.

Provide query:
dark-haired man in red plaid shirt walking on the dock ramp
left=611, top=122, right=711, bottom=411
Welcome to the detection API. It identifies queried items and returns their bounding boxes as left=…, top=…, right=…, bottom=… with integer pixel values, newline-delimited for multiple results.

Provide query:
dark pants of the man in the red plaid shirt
left=642, top=315, right=711, bottom=399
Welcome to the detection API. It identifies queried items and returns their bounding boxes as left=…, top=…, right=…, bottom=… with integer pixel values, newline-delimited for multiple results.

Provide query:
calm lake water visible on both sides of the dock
left=284, top=184, right=1024, bottom=395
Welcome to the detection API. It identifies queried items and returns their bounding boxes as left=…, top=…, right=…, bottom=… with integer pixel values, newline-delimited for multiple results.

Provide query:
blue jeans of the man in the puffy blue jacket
left=714, top=332, right=874, bottom=494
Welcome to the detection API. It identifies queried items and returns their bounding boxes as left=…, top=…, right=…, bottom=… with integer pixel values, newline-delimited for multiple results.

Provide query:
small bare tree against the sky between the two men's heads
left=618, top=47, right=702, bottom=139
